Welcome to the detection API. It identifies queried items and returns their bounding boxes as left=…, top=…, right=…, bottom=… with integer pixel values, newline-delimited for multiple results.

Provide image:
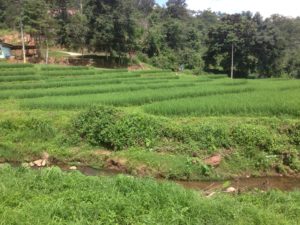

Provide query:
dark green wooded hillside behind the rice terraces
left=0, top=0, right=300, bottom=78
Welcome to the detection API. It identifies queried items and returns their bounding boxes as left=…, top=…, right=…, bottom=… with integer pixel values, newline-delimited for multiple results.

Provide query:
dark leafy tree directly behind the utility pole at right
left=205, top=14, right=257, bottom=77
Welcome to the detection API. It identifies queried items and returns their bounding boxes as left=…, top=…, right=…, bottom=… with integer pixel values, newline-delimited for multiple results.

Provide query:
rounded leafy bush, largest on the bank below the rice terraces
left=72, top=106, right=160, bottom=150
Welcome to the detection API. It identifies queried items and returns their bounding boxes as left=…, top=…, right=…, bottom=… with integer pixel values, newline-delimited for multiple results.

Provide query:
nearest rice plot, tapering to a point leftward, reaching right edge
left=144, top=90, right=300, bottom=117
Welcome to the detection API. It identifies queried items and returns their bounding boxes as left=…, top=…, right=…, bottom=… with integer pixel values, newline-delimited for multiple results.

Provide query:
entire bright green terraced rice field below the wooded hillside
left=0, top=64, right=300, bottom=117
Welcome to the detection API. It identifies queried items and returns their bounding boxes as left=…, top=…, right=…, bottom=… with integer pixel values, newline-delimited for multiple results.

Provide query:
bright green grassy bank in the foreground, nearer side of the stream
left=0, top=165, right=300, bottom=225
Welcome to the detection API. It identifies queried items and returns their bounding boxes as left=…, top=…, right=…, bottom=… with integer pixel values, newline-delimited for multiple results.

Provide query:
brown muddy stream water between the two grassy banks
left=69, top=167, right=300, bottom=192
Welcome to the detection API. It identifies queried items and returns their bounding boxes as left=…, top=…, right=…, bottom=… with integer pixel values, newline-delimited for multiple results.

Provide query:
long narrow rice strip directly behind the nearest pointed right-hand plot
left=22, top=85, right=254, bottom=109
